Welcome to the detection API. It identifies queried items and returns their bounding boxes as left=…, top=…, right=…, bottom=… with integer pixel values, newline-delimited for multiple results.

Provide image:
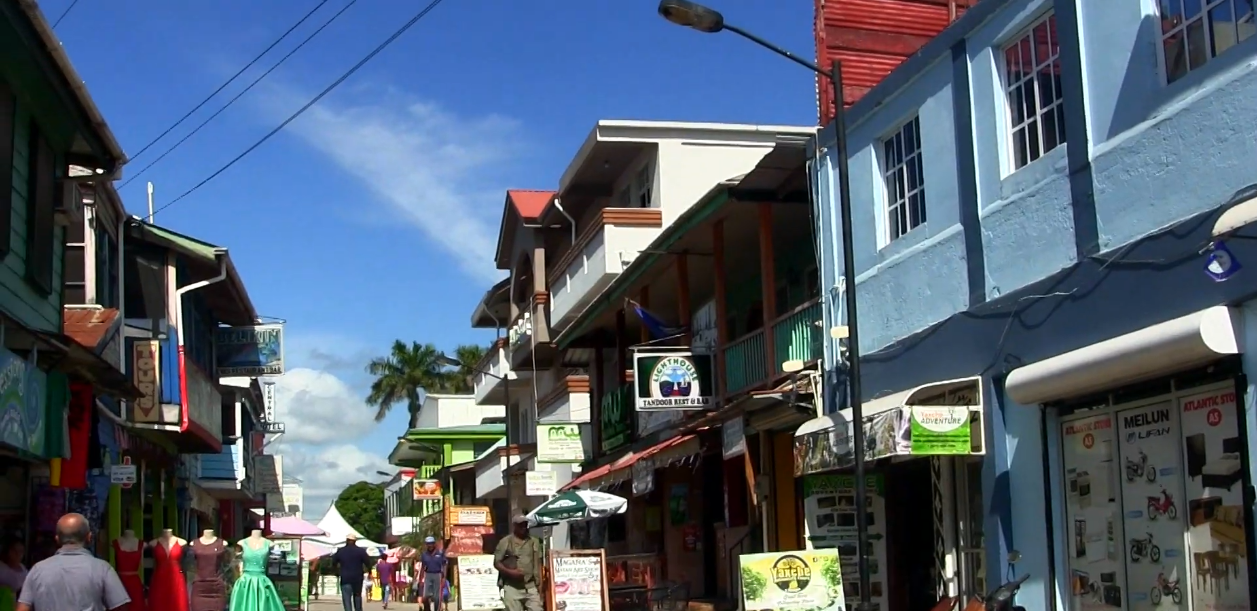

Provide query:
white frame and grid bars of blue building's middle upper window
left=998, top=11, right=1067, bottom=173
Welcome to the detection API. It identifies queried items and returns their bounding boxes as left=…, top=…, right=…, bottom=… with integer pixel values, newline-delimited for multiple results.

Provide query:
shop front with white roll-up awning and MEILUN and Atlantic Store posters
left=1004, top=307, right=1257, bottom=611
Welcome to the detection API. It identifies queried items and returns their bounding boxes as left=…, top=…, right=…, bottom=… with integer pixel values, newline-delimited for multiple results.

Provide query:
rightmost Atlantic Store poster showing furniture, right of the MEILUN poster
left=1179, top=388, right=1251, bottom=611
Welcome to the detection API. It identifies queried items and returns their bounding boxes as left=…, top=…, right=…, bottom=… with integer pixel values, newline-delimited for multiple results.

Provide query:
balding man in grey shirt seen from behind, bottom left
left=18, top=513, right=131, bottom=611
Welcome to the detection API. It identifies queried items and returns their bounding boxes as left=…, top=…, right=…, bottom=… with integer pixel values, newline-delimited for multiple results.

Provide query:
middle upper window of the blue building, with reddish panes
left=1004, top=14, right=1065, bottom=170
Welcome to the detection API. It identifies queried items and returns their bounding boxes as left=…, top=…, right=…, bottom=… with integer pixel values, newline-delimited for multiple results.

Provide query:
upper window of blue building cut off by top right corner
left=1160, top=0, right=1257, bottom=83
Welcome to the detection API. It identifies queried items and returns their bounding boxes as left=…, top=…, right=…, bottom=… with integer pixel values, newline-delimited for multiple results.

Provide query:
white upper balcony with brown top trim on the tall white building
left=547, top=207, right=664, bottom=331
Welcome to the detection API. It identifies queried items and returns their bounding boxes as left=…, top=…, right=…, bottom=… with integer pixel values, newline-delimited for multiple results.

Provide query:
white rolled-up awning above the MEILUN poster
left=1004, top=306, right=1243, bottom=405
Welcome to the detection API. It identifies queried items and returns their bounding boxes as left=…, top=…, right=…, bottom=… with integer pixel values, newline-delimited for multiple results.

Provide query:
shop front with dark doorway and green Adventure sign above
left=794, top=377, right=985, bottom=611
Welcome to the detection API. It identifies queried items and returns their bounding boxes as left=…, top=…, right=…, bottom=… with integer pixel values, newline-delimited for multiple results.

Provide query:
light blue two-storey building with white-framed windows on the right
left=796, top=0, right=1257, bottom=611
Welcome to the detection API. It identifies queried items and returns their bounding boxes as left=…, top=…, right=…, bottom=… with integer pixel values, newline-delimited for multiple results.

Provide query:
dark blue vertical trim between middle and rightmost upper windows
left=1053, top=0, right=1100, bottom=260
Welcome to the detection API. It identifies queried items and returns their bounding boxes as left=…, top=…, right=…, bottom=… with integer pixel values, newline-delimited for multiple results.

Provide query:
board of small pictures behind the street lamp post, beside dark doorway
left=799, top=474, right=889, bottom=610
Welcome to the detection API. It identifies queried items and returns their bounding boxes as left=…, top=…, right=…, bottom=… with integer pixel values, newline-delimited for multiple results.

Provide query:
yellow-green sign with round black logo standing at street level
left=738, top=549, right=844, bottom=611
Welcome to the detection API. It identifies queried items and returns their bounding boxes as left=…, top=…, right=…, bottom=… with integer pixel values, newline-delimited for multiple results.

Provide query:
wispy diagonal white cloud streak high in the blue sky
left=273, top=87, right=519, bottom=282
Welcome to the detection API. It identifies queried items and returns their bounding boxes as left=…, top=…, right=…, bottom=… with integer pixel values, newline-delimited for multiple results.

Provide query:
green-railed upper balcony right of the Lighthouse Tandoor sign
left=724, top=299, right=823, bottom=395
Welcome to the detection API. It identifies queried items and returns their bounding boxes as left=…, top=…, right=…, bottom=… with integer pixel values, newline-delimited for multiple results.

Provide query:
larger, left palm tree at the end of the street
left=367, top=339, right=453, bottom=422
